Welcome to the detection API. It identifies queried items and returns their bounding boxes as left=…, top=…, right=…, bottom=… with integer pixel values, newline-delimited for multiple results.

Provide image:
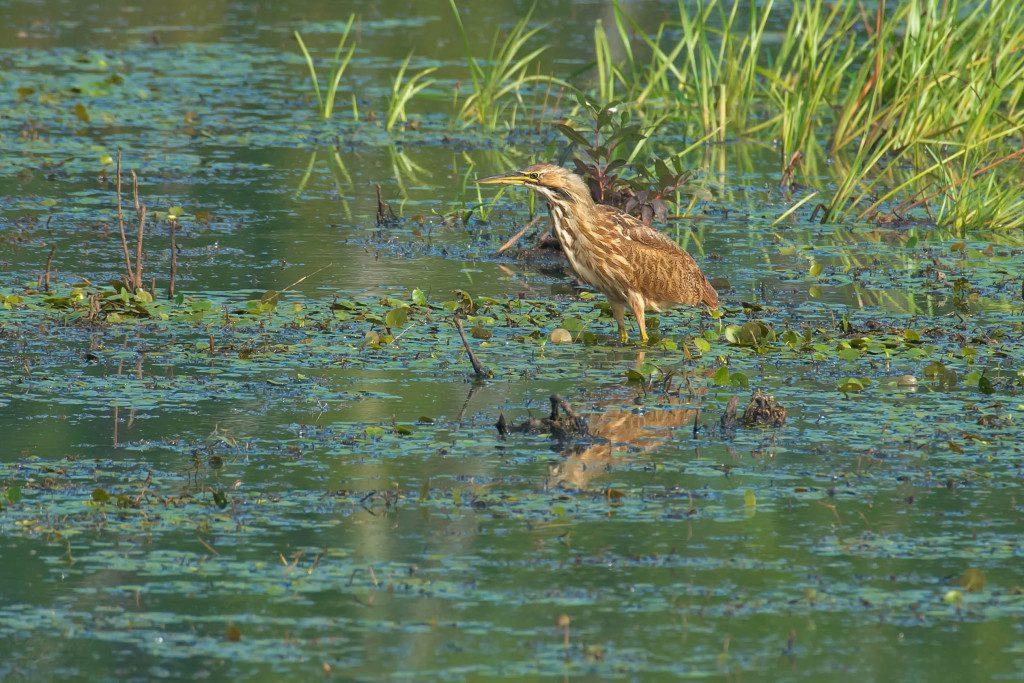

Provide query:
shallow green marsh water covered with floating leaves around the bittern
left=0, top=2, right=1024, bottom=680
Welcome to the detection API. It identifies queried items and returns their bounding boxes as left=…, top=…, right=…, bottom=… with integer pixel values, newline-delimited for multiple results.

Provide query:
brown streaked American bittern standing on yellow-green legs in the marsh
left=478, top=164, right=718, bottom=343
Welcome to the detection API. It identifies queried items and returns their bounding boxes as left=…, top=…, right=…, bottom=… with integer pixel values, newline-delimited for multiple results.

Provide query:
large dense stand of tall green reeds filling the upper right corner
left=577, top=0, right=1024, bottom=231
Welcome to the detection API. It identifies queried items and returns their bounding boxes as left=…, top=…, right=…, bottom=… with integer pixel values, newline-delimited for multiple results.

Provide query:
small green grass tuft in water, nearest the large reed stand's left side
left=449, top=0, right=564, bottom=130
